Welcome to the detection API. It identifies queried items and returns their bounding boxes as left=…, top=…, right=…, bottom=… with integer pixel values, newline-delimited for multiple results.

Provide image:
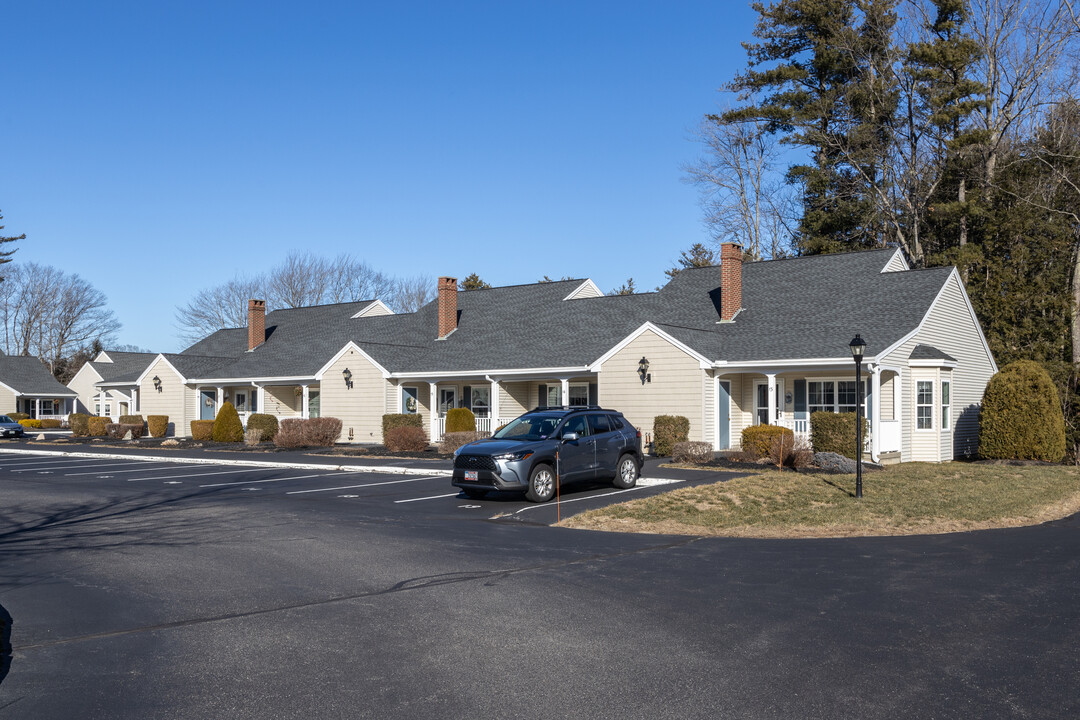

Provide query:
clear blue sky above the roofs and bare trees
left=0, top=0, right=755, bottom=351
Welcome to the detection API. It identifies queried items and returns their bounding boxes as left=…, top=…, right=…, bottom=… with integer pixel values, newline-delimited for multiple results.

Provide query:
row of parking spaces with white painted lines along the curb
left=0, top=449, right=699, bottom=525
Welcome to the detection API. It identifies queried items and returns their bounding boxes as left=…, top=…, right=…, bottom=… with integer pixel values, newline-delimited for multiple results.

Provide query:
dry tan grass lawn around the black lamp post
left=562, top=462, right=1080, bottom=538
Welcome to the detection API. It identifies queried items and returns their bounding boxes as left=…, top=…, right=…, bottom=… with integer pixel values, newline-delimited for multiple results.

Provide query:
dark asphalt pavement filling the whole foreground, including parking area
left=0, top=446, right=1080, bottom=719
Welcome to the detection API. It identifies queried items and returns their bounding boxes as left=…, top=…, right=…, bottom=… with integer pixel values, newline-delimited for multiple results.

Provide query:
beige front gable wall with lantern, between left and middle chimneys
left=320, top=349, right=388, bottom=443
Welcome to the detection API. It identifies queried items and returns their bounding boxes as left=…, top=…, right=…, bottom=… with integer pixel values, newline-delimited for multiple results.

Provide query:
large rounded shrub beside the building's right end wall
left=978, top=361, right=1065, bottom=462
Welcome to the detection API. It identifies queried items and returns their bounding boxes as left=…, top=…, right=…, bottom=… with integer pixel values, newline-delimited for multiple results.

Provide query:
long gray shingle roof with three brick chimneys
left=174, top=249, right=951, bottom=379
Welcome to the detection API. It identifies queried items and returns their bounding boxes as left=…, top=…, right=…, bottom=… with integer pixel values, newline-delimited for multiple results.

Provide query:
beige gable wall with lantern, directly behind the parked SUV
left=597, top=330, right=713, bottom=443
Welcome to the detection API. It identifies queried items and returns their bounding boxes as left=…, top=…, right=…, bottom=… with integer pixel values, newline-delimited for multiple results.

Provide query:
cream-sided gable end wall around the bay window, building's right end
left=881, top=273, right=995, bottom=461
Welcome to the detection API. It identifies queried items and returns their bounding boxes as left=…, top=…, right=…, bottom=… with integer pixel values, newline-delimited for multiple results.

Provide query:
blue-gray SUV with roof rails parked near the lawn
left=453, top=406, right=645, bottom=502
